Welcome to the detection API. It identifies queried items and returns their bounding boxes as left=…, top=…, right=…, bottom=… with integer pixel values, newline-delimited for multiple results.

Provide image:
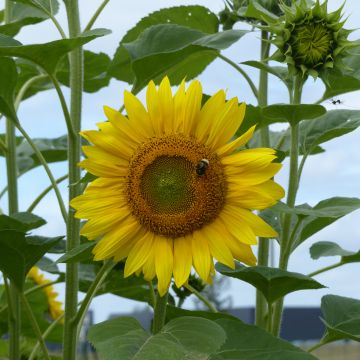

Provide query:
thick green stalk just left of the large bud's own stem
left=255, top=31, right=270, bottom=329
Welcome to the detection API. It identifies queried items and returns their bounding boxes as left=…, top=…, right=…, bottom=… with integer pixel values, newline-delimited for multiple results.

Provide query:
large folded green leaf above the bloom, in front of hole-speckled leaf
left=124, top=25, right=247, bottom=92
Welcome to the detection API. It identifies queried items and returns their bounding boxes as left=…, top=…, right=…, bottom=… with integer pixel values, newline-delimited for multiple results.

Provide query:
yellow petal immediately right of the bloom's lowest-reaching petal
left=174, top=236, right=192, bottom=287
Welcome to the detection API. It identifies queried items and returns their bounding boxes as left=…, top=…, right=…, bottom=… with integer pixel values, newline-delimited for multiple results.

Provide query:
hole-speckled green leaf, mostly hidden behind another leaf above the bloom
left=109, top=5, right=219, bottom=83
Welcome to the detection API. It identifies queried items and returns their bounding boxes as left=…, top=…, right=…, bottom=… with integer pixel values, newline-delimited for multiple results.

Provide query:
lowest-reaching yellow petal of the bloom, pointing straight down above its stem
left=154, top=236, right=174, bottom=296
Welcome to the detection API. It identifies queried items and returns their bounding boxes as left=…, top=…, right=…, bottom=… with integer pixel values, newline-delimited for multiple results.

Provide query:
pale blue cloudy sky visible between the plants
left=0, top=0, right=360, bottom=322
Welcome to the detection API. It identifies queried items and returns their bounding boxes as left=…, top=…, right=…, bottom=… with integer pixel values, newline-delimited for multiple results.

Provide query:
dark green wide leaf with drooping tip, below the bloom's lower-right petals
left=215, top=263, right=325, bottom=303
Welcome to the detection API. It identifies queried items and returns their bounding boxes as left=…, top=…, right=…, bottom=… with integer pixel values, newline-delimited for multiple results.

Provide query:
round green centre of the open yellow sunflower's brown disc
left=141, top=156, right=194, bottom=213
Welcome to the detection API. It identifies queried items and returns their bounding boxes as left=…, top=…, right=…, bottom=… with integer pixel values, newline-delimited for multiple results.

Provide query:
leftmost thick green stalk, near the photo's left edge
left=4, top=0, right=21, bottom=360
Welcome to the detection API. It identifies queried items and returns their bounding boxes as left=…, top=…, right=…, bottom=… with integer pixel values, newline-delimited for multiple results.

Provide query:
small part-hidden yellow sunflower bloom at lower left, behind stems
left=27, top=266, right=64, bottom=320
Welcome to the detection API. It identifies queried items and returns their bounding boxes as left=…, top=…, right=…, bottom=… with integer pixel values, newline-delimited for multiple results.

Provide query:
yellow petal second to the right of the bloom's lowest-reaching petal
left=192, top=230, right=211, bottom=281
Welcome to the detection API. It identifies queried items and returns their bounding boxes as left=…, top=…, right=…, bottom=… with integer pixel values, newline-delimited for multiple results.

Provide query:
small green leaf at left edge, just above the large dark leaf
left=0, top=212, right=46, bottom=233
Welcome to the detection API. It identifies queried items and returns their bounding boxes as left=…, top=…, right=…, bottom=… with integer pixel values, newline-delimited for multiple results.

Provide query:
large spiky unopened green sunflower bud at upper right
left=269, top=0, right=352, bottom=80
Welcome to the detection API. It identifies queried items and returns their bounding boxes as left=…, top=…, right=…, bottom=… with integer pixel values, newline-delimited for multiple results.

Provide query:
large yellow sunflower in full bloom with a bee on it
left=71, top=77, right=284, bottom=295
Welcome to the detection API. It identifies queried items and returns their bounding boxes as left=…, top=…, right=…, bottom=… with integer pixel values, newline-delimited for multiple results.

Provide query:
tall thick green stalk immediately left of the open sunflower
left=63, top=0, right=83, bottom=360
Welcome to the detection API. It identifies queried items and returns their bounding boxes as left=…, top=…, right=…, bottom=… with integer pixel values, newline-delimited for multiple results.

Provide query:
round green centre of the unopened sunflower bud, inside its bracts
left=289, top=20, right=334, bottom=68
